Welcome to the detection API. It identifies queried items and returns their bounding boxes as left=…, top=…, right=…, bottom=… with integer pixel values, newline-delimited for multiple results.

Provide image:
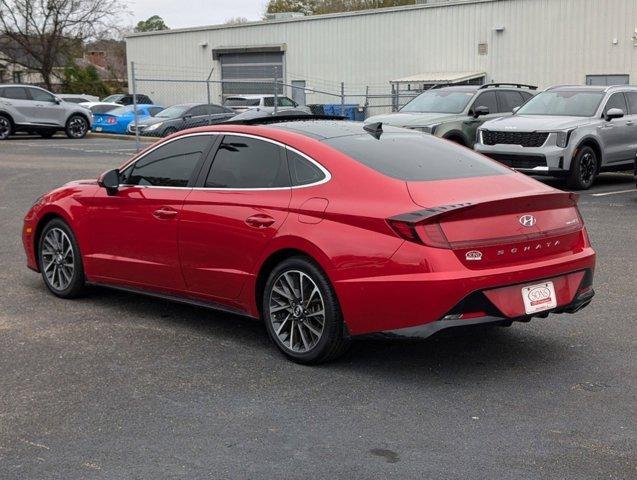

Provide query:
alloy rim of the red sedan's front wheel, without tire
left=42, top=228, right=75, bottom=291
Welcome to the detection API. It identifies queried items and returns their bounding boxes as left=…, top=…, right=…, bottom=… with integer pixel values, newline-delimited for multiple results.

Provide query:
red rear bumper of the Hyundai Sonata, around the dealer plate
left=335, top=247, right=595, bottom=335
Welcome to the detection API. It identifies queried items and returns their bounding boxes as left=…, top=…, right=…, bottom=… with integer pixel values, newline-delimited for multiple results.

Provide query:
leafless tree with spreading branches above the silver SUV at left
left=0, top=0, right=125, bottom=88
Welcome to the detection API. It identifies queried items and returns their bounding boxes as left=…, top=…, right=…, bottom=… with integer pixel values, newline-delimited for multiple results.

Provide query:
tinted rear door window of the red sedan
left=206, top=135, right=290, bottom=188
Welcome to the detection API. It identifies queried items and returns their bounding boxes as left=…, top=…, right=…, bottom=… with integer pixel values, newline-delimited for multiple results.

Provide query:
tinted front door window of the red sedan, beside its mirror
left=121, top=135, right=212, bottom=187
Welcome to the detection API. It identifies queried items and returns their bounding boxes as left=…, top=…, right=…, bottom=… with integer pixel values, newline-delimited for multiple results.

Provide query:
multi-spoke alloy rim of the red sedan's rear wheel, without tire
left=269, top=270, right=325, bottom=353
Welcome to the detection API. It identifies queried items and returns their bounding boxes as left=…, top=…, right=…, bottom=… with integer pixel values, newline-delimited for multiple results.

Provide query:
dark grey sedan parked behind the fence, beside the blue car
left=128, top=103, right=236, bottom=137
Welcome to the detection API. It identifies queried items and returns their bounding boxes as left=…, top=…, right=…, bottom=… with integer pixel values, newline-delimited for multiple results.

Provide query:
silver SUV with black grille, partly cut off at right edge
left=475, top=86, right=637, bottom=189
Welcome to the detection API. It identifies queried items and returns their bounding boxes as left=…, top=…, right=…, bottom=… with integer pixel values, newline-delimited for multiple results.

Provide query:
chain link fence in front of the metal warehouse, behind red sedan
left=94, top=63, right=428, bottom=148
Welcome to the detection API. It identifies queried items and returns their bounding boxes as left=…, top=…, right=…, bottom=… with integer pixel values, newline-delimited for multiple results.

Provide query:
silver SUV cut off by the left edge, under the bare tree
left=0, top=85, right=91, bottom=140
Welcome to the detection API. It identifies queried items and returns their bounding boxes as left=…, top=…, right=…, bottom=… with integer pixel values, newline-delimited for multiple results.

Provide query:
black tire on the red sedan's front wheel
left=38, top=218, right=86, bottom=298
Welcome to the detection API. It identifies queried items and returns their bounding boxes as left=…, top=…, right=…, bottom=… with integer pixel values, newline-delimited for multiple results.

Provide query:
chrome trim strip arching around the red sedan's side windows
left=119, top=131, right=332, bottom=192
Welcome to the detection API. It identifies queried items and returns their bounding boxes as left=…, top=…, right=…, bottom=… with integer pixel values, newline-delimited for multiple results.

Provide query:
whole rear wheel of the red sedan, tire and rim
left=263, top=257, right=349, bottom=364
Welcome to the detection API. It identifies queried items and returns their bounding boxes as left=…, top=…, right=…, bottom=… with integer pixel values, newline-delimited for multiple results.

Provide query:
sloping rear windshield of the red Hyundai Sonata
left=324, top=133, right=510, bottom=181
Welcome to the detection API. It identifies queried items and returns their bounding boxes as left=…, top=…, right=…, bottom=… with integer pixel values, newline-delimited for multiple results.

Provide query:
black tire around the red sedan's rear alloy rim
left=262, top=256, right=350, bottom=365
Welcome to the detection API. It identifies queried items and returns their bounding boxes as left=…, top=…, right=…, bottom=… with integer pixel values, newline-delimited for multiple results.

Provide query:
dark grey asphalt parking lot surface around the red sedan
left=0, top=137, right=637, bottom=480
